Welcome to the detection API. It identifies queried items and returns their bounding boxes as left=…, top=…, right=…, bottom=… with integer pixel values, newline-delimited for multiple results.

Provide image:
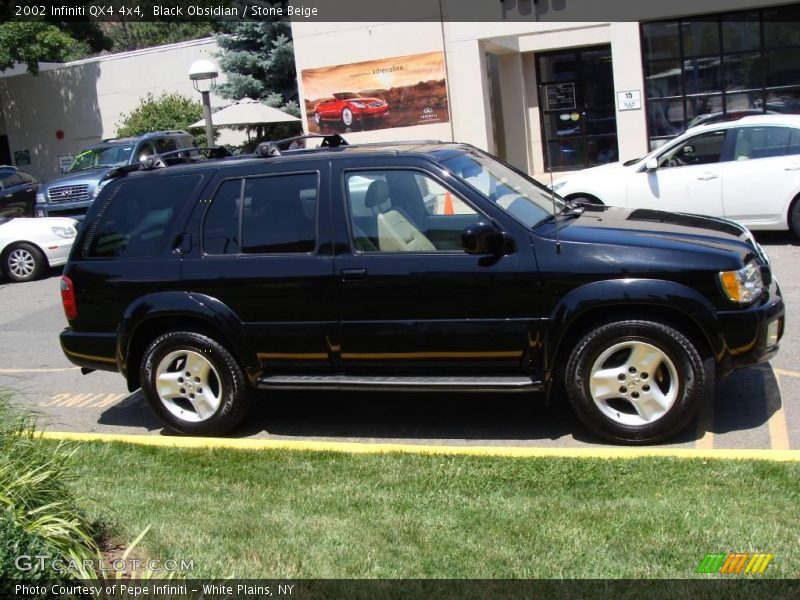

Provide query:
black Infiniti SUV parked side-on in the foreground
left=61, top=136, right=784, bottom=443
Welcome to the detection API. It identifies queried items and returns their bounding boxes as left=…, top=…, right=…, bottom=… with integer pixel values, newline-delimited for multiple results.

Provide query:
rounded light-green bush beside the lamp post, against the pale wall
left=117, top=93, right=207, bottom=147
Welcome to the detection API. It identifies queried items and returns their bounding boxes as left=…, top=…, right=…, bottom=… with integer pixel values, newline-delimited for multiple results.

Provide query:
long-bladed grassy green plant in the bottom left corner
left=0, top=395, right=98, bottom=580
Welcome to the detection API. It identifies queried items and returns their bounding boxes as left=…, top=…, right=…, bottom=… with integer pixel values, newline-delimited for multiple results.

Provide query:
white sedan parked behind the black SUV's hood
left=553, top=115, right=800, bottom=237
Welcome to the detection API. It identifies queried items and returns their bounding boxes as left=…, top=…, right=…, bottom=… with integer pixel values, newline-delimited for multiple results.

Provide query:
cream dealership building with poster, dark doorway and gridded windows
left=292, top=0, right=800, bottom=174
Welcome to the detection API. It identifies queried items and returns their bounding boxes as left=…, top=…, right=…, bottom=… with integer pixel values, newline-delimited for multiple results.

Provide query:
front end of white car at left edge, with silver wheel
left=0, top=217, right=77, bottom=282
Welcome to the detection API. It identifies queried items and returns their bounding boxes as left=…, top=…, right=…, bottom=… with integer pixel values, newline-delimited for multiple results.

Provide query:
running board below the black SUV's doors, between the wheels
left=258, top=375, right=544, bottom=392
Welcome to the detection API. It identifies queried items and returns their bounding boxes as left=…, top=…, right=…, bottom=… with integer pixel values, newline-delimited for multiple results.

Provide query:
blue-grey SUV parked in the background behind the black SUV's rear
left=36, top=131, right=197, bottom=220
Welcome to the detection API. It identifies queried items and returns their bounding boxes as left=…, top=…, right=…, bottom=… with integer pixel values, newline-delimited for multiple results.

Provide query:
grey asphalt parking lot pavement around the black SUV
left=0, top=232, right=800, bottom=450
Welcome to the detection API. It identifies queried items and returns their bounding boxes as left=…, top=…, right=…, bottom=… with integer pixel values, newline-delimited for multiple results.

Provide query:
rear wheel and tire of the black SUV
left=140, top=331, right=252, bottom=435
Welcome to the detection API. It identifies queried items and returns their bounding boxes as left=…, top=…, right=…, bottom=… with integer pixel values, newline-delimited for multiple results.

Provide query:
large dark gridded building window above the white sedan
left=642, top=4, right=800, bottom=148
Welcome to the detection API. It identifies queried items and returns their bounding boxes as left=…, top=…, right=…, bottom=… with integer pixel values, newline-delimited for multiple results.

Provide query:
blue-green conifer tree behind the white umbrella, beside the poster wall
left=216, top=21, right=300, bottom=116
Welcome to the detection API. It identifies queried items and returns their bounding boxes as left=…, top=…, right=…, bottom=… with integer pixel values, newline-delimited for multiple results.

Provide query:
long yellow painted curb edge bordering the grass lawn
left=34, top=431, right=800, bottom=462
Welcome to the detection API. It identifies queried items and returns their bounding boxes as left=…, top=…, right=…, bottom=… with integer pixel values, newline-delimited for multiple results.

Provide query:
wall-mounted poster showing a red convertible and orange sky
left=301, top=52, right=450, bottom=133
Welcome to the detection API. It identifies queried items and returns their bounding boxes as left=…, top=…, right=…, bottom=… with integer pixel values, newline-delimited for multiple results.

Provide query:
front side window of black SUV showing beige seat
left=345, top=169, right=488, bottom=252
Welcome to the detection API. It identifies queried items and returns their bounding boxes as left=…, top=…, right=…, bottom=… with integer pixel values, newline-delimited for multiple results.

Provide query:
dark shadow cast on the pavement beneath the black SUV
left=98, top=365, right=781, bottom=445
